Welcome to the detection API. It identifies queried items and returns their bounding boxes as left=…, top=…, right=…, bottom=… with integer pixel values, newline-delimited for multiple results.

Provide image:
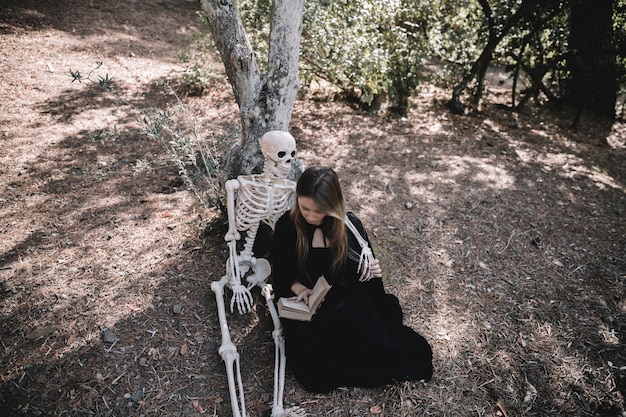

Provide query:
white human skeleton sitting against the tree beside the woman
left=211, top=131, right=305, bottom=417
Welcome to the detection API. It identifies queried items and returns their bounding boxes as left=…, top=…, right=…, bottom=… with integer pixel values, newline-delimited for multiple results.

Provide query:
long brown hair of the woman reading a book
left=291, top=166, right=348, bottom=278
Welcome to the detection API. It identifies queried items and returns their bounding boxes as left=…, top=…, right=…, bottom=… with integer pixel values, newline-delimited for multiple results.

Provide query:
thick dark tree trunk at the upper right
left=566, top=0, right=617, bottom=118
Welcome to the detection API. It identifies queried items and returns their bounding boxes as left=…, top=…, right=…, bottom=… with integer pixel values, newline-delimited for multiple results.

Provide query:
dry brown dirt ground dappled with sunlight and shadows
left=0, top=0, right=626, bottom=417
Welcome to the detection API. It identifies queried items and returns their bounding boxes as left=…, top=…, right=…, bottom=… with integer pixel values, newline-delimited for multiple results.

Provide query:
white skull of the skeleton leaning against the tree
left=261, top=130, right=296, bottom=178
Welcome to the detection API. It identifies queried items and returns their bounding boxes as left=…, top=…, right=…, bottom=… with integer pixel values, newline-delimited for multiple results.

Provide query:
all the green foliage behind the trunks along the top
left=228, top=0, right=626, bottom=113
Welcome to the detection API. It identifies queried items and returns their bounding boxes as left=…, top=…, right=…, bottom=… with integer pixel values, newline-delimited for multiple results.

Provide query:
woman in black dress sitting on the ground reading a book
left=272, top=167, right=433, bottom=392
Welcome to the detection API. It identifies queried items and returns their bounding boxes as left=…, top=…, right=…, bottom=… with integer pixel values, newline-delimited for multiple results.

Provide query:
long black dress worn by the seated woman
left=272, top=213, right=433, bottom=392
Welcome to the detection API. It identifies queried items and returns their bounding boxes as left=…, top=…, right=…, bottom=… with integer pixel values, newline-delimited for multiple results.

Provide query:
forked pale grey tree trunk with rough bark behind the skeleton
left=199, top=0, right=304, bottom=178
